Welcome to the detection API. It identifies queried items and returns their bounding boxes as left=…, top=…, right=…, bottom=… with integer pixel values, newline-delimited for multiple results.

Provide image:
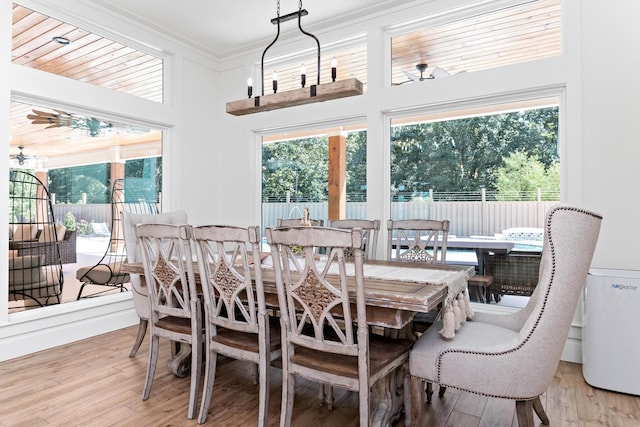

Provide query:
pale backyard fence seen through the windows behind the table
left=262, top=201, right=558, bottom=237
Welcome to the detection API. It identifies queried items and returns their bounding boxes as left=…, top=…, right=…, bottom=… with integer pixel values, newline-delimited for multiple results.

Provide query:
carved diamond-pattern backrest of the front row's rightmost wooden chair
left=267, top=227, right=368, bottom=363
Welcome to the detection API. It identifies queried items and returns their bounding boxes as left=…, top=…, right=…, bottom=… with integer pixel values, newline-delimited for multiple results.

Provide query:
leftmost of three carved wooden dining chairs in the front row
left=136, top=224, right=203, bottom=419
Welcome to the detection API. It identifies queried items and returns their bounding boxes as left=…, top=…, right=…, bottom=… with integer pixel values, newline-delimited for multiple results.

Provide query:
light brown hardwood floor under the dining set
left=0, top=326, right=640, bottom=427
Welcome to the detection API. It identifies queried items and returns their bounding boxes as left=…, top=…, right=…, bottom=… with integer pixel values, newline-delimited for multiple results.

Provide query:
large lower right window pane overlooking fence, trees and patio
left=390, top=98, right=560, bottom=306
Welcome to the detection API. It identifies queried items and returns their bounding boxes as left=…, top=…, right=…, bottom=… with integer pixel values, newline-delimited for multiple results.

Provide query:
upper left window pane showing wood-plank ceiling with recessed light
left=12, top=4, right=163, bottom=102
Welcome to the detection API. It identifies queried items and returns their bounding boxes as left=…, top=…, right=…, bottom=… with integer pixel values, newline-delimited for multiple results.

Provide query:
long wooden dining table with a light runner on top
left=123, top=260, right=475, bottom=426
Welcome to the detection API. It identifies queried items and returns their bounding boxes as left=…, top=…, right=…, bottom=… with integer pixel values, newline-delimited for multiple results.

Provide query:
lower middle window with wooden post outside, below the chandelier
left=262, top=125, right=367, bottom=231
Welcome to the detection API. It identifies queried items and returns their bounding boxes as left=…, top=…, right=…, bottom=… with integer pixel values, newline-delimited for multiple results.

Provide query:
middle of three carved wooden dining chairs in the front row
left=193, top=225, right=281, bottom=426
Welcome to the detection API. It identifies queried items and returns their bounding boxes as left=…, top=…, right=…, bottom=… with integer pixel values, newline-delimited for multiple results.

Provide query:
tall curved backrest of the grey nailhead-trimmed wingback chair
left=504, top=205, right=602, bottom=396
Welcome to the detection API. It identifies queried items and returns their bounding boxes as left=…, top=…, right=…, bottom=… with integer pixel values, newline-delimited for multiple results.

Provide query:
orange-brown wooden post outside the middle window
left=328, top=134, right=347, bottom=220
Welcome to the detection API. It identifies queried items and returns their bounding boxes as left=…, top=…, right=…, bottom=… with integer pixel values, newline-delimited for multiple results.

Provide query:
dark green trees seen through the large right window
left=391, top=107, right=558, bottom=194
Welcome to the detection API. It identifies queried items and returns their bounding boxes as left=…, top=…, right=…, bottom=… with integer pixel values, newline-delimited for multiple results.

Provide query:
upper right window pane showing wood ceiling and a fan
left=391, top=0, right=562, bottom=85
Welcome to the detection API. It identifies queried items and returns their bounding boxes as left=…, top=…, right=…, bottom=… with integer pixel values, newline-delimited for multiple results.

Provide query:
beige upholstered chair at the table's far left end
left=120, top=210, right=187, bottom=357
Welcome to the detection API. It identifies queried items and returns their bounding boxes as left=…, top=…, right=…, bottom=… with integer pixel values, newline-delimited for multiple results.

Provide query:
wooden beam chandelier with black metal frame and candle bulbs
left=227, top=0, right=362, bottom=116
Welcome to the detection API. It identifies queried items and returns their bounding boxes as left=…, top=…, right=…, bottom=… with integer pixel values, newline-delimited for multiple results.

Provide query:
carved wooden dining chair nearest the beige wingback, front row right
left=266, top=227, right=412, bottom=426
